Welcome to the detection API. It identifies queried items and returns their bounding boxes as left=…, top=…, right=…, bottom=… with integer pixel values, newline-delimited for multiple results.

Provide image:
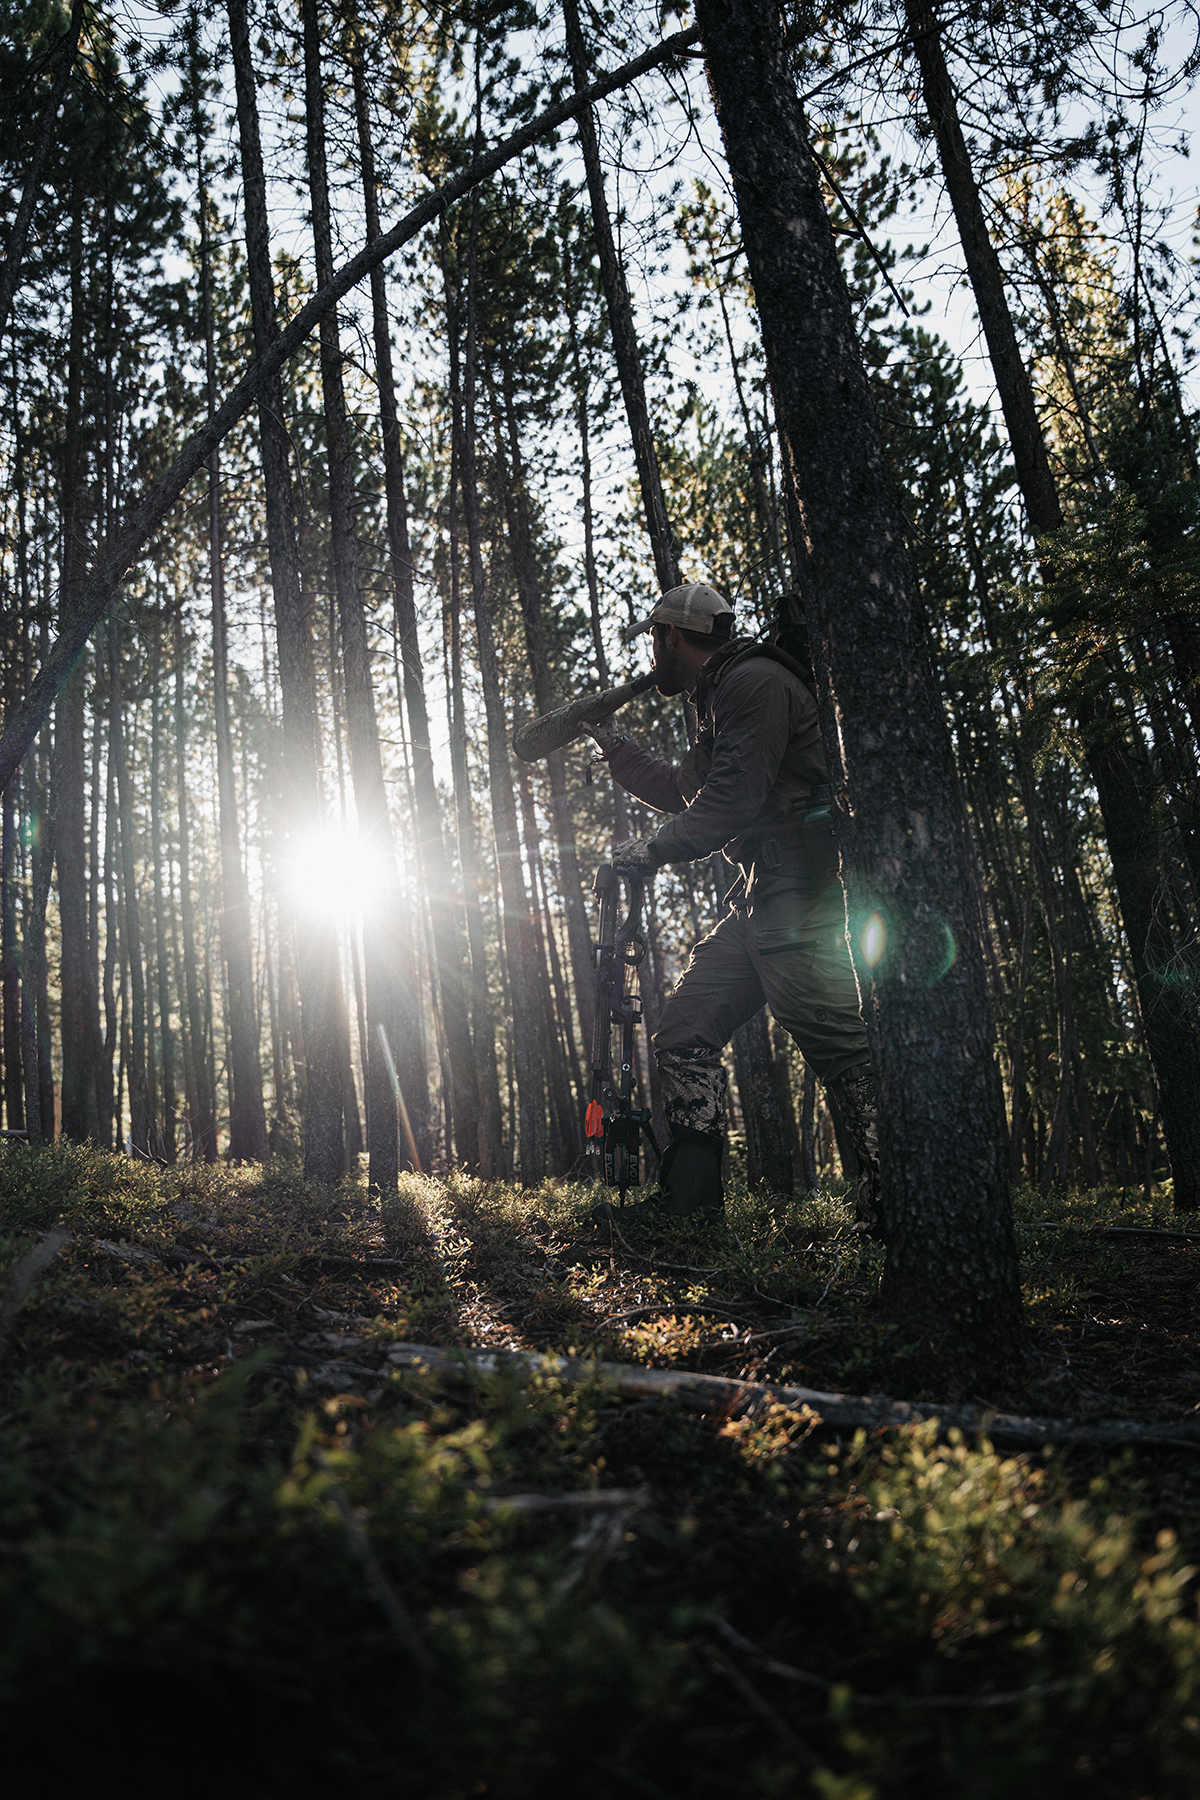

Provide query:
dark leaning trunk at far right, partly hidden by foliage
left=909, top=0, right=1200, bottom=1211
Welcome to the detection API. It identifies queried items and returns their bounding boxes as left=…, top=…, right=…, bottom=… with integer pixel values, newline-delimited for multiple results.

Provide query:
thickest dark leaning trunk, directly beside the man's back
left=698, top=0, right=1020, bottom=1368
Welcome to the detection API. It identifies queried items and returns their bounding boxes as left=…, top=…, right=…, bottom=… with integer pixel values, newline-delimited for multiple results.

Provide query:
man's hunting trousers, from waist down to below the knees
left=655, top=882, right=871, bottom=1132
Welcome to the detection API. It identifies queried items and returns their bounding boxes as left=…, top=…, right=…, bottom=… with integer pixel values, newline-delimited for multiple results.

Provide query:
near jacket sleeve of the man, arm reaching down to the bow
left=649, top=657, right=792, bottom=864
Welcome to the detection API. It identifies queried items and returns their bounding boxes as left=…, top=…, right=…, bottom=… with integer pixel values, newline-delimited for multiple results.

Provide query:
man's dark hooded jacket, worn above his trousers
left=608, top=639, right=829, bottom=877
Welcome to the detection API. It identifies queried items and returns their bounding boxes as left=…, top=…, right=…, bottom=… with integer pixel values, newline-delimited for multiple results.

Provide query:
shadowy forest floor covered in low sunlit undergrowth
left=0, top=1145, right=1200, bottom=1800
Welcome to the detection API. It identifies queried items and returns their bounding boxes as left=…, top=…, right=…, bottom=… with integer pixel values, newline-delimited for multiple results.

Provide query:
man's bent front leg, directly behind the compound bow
left=653, top=913, right=763, bottom=1213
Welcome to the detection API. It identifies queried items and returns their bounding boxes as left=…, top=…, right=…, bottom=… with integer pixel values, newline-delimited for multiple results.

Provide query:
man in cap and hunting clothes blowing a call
left=588, top=583, right=882, bottom=1235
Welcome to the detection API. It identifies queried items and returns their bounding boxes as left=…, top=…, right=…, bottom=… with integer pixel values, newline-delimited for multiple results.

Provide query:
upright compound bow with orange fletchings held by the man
left=585, top=862, right=662, bottom=1206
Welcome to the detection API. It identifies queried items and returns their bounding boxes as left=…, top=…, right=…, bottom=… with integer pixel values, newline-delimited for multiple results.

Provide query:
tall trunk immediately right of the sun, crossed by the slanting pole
left=302, top=0, right=428, bottom=1192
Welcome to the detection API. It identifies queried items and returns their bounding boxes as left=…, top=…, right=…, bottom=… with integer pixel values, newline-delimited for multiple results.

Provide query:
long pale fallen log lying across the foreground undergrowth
left=387, top=1345, right=1200, bottom=1451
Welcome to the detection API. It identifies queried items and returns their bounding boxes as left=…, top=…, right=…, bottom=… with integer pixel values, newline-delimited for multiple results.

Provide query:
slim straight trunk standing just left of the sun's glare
left=196, top=151, right=266, bottom=1163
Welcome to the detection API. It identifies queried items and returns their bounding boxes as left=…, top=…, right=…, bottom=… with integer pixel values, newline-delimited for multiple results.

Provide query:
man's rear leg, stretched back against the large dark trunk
left=750, top=882, right=883, bottom=1237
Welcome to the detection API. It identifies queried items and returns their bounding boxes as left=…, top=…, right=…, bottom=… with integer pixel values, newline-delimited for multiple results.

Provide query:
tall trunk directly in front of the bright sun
left=230, top=0, right=342, bottom=1183
